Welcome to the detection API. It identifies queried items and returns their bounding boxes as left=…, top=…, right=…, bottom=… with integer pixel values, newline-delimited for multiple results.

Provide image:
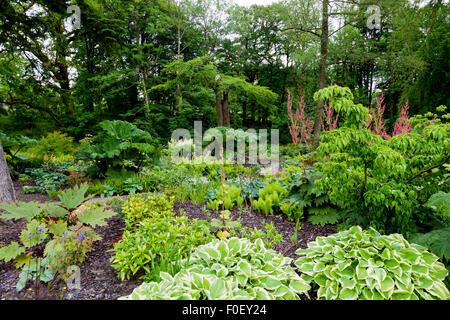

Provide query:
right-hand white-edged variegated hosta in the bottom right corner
left=295, top=226, right=450, bottom=300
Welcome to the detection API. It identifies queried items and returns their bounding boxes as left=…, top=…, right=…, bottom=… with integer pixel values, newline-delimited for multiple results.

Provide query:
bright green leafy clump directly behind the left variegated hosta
left=111, top=215, right=213, bottom=281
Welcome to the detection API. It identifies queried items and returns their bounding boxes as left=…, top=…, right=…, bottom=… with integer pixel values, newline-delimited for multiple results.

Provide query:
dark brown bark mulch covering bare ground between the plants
left=0, top=183, right=336, bottom=300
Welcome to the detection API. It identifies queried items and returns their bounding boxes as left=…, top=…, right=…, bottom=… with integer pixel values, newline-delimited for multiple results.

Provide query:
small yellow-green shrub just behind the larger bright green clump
left=122, top=194, right=175, bottom=228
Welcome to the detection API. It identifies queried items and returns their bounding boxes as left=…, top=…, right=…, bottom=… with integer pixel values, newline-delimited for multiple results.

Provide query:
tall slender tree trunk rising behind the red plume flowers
left=313, top=0, right=330, bottom=147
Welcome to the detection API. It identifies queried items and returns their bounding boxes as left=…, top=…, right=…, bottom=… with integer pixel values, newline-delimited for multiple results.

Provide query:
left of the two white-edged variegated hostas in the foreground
left=121, top=238, right=310, bottom=300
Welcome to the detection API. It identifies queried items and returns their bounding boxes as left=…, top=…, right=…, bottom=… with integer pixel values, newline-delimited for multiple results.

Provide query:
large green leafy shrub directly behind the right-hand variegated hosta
left=315, top=86, right=450, bottom=235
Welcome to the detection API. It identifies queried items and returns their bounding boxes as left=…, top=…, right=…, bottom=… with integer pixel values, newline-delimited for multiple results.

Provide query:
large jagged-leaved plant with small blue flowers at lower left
left=0, top=185, right=115, bottom=291
